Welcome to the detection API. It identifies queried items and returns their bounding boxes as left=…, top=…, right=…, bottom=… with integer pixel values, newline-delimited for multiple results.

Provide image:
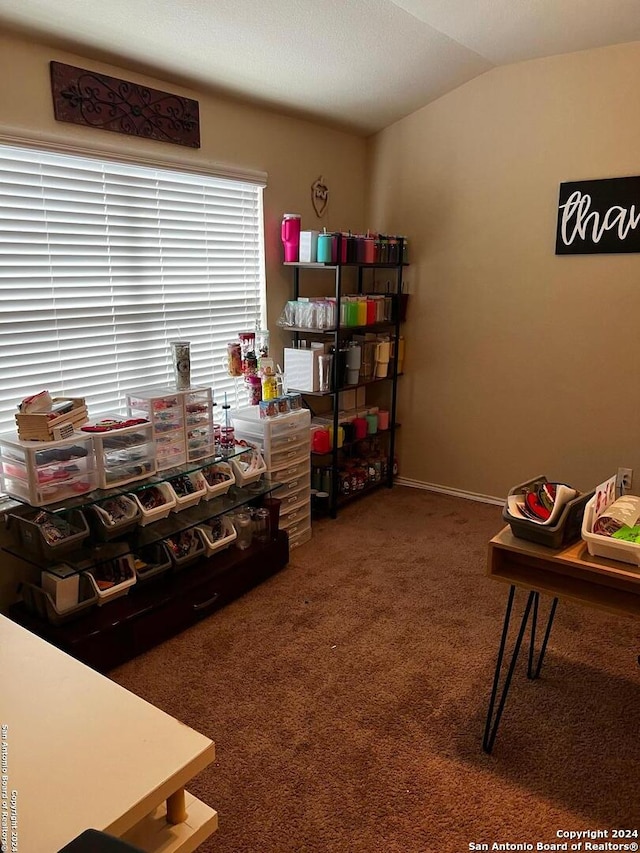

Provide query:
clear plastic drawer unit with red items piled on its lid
left=82, top=417, right=156, bottom=489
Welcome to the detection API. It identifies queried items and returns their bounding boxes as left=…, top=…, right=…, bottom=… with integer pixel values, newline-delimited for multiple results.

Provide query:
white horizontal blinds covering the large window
left=0, top=145, right=264, bottom=431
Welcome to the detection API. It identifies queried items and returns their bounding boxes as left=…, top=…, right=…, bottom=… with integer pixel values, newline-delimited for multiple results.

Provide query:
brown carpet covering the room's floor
left=110, top=486, right=640, bottom=853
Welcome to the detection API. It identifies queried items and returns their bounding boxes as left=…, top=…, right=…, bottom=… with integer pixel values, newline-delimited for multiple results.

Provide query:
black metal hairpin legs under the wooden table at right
left=482, top=585, right=558, bottom=753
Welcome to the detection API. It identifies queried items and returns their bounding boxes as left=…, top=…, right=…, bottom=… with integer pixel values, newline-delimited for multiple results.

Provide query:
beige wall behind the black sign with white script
left=369, top=43, right=640, bottom=497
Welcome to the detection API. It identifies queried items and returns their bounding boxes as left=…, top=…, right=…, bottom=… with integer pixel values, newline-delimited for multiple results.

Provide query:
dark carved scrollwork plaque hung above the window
left=50, top=62, right=200, bottom=148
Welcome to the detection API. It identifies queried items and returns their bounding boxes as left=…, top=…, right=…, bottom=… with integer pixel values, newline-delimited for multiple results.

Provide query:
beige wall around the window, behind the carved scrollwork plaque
left=0, top=35, right=366, bottom=609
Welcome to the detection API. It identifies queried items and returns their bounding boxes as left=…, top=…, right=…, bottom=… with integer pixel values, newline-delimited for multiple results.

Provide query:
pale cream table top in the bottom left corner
left=0, top=616, right=214, bottom=853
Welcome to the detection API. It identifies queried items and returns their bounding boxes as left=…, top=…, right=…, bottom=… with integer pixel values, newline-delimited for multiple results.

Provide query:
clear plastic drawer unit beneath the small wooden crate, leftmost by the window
left=0, top=432, right=98, bottom=506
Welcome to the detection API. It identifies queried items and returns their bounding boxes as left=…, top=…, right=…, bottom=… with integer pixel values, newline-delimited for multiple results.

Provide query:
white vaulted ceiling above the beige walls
left=0, top=0, right=640, bottom=135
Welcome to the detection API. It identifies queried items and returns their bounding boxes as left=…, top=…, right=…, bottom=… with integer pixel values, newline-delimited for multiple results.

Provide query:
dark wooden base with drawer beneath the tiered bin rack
left=9, top=531, right=289, bottom=672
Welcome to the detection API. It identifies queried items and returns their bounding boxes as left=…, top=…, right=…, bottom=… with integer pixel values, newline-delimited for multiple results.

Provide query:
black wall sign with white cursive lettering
left=556, top=177, right=640, bottom=255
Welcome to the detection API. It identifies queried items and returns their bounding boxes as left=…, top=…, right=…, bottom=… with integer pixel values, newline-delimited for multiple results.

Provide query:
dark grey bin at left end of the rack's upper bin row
left=7, top=510, right=89, bottom=560
